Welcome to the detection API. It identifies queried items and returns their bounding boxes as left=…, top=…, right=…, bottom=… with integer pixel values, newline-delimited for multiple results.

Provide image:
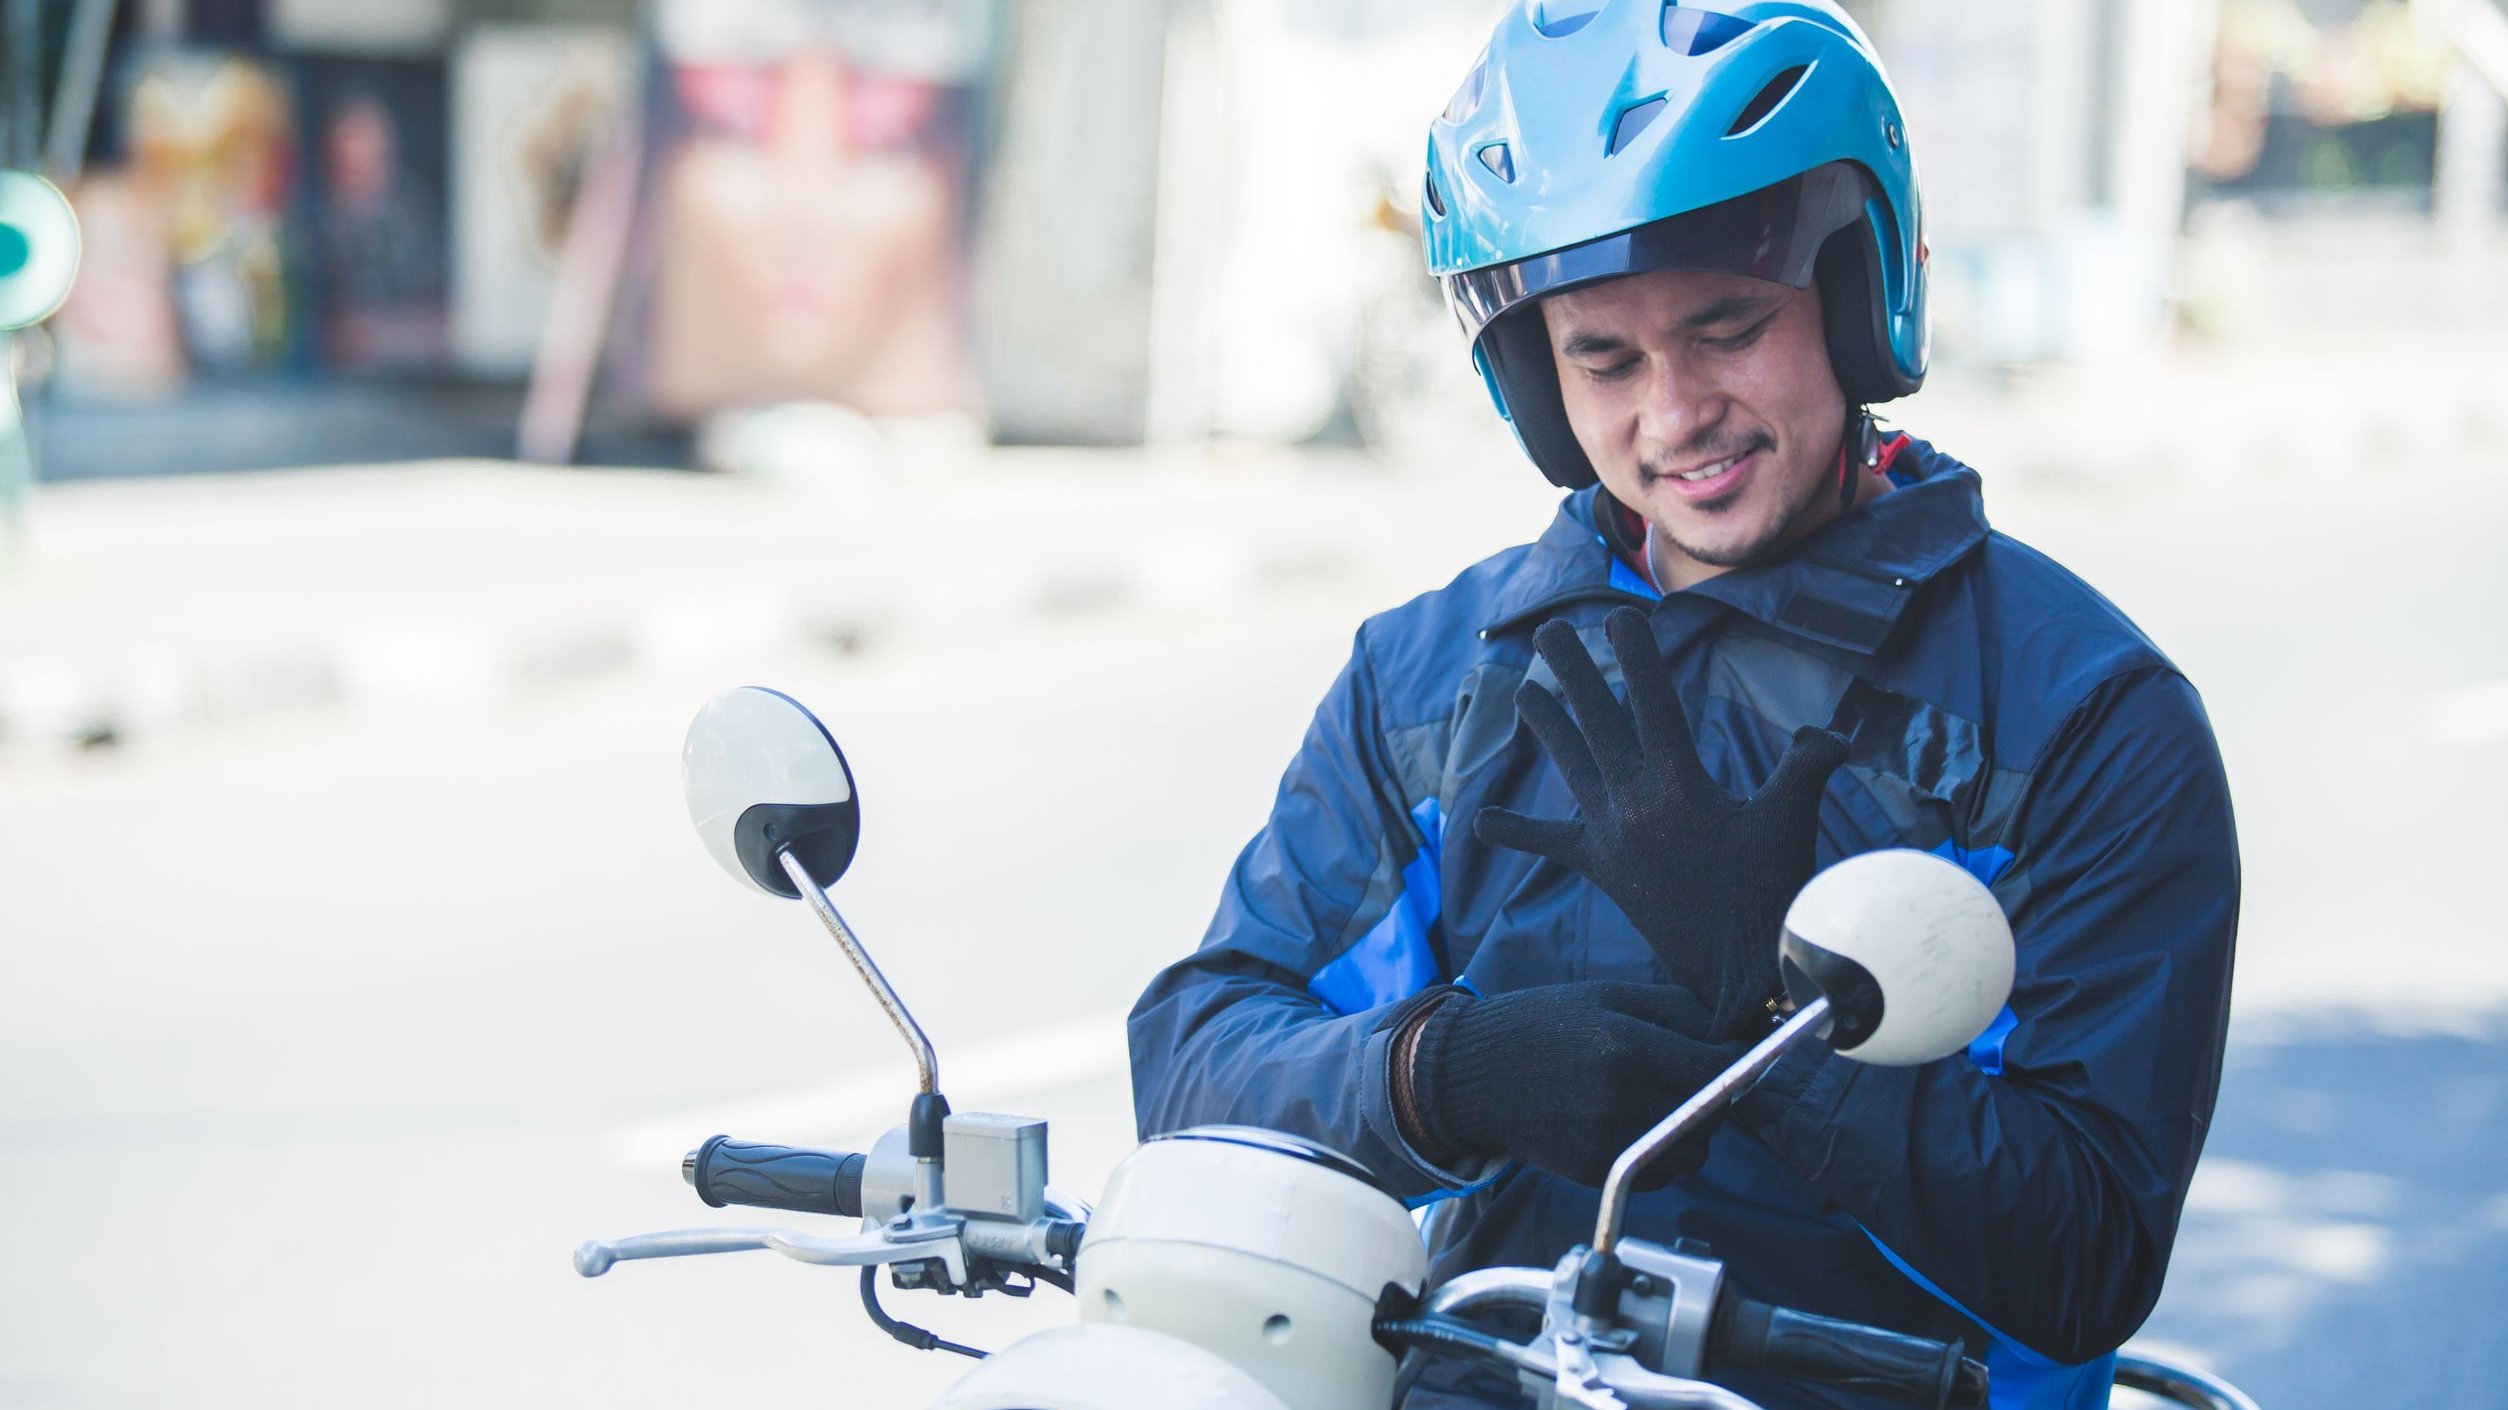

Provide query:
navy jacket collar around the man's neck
left=1480, top=442, right=1986, bottom=655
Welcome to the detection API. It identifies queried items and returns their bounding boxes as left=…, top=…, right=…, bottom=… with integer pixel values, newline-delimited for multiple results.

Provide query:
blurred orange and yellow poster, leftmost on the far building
left=115, top=50, right=296, bottom=371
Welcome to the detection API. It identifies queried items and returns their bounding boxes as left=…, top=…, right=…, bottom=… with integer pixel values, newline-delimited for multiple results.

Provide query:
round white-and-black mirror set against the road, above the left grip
left=680, top=685, right=863, bottom=898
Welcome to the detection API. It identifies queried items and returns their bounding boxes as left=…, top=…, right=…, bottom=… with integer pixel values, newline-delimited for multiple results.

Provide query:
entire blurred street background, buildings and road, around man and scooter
left=0, top=0, right=2508, bottom=1410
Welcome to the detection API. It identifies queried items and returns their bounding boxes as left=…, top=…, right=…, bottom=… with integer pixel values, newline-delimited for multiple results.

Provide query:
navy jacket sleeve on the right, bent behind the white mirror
left=1736, top=667, right=2240, bottom=1365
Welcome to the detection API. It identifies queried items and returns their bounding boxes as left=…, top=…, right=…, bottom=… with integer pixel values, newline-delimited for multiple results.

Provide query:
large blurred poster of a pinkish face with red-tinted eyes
left=645, top=0, right=993, bottom=419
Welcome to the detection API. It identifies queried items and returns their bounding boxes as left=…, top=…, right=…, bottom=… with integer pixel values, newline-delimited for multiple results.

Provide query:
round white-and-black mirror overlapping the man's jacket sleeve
left=1783, top=848, right=2011, bottom=1066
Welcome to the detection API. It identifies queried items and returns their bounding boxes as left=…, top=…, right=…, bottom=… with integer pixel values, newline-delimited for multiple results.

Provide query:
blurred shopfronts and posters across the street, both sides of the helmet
left=0, top=0, right=2508, bottom=474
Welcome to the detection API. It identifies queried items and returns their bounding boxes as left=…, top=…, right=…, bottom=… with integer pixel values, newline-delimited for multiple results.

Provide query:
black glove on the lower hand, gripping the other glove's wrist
left=1409, top=981, right=1748, bottom=1187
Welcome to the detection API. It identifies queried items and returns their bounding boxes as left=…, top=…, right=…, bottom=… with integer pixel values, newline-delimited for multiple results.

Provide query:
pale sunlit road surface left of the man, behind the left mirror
left=0, top=594, right=1347, bottom=1407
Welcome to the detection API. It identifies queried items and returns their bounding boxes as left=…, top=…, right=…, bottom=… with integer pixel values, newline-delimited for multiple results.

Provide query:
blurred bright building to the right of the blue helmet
left=1863, top=0, right=2508, bottom=366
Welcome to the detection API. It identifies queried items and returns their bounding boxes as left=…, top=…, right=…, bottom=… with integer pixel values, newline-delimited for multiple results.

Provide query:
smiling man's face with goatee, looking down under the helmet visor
left=1540, top=273, right=1846, bottom=587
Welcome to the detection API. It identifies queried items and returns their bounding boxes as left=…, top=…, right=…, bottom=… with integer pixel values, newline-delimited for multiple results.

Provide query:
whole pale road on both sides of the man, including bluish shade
left=0, top=469, right=2508, bottom=1410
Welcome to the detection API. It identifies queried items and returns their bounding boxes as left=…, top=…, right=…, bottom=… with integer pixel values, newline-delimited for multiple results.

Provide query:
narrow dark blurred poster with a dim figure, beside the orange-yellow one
left=296, top=58, right=449, bottom=371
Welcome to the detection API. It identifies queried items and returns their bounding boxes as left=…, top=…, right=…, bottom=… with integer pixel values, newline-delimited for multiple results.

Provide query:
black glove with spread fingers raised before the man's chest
left=1472, top=607, right=1846, bottom=1039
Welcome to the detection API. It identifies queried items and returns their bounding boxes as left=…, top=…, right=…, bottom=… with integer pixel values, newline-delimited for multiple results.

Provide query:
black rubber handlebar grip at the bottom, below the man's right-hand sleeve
left=1710, top=1297, right=1986, bottom=1410
